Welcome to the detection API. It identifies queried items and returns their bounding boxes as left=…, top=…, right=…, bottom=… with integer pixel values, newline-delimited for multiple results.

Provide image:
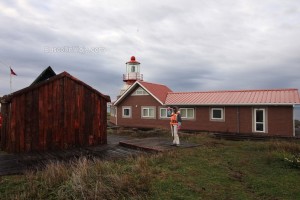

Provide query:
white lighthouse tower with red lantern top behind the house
left=120, top=56, right=143, bottom=95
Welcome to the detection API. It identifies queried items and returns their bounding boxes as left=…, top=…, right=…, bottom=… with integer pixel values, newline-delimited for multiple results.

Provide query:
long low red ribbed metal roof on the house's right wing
left=165, top=89, right=300, bottom=105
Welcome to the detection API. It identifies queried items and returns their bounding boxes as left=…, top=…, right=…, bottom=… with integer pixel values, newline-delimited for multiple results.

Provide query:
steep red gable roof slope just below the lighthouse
left=138, top=81, right=172, bottom=104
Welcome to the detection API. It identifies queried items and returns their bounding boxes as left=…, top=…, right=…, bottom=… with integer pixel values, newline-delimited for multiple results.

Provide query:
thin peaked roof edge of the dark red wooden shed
left=1, top=71, right=110, bottom=102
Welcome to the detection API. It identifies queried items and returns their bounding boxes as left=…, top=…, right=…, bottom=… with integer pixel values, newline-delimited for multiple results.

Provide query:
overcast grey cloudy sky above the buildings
left=0, top=0, right=300, bottom=100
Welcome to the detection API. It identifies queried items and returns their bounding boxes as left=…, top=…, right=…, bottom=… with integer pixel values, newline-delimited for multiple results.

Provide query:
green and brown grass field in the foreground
left=0, top=131, right=300, bottom=200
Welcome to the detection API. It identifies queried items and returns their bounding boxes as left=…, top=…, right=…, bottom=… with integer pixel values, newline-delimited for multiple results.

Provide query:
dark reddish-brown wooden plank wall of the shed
left=1, top=76, right=107, bottom=153
